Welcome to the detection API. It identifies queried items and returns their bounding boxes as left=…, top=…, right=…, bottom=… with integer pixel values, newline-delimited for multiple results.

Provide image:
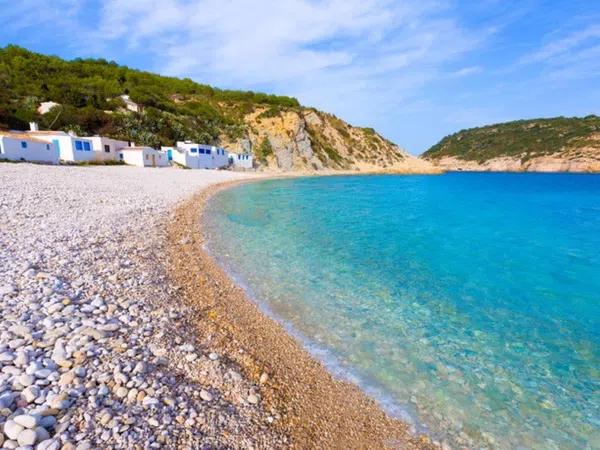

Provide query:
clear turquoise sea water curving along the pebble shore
left=207, top=173, right=600, bottom=449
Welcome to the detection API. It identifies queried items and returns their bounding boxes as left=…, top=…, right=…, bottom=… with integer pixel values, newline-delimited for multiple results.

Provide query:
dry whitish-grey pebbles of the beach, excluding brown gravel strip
left=0, top=164, right=284, bottom=450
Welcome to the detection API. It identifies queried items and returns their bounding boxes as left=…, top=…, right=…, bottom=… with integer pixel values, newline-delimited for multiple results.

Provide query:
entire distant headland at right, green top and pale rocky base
left=422, top=115, right=600, bottom=172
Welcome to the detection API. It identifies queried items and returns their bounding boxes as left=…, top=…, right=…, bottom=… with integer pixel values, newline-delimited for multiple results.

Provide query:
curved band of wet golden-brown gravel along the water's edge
left=167, top=178, right=435, bottom=449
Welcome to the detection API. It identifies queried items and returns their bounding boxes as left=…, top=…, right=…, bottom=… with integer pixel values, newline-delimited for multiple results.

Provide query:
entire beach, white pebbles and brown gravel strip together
left=0, top=164, right=430, bottom=450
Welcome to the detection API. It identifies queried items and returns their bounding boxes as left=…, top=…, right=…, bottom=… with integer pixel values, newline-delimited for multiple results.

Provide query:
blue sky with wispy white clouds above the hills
left=0, top=0, right=600, bottom=154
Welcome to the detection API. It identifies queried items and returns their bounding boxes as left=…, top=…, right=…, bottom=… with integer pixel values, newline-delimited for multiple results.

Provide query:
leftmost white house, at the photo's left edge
left=0, top=131, right=59, bottom=164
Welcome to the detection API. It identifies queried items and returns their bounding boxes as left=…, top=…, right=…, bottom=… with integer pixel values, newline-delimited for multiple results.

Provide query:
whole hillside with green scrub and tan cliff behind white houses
left=0, top=46, right=432, bottom=171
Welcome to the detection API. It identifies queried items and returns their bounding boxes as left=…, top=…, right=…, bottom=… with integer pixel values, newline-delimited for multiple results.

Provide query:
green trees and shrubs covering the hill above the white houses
left=0, top=45, right=300, bottom=146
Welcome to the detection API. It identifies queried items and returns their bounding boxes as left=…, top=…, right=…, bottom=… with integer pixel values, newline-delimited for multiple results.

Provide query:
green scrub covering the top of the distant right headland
left=423, top=115, right=600, bottom=162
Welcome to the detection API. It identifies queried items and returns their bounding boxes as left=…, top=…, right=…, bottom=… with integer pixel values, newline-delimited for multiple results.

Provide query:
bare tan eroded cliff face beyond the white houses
left=221, top=108, right=439, bottom=173
